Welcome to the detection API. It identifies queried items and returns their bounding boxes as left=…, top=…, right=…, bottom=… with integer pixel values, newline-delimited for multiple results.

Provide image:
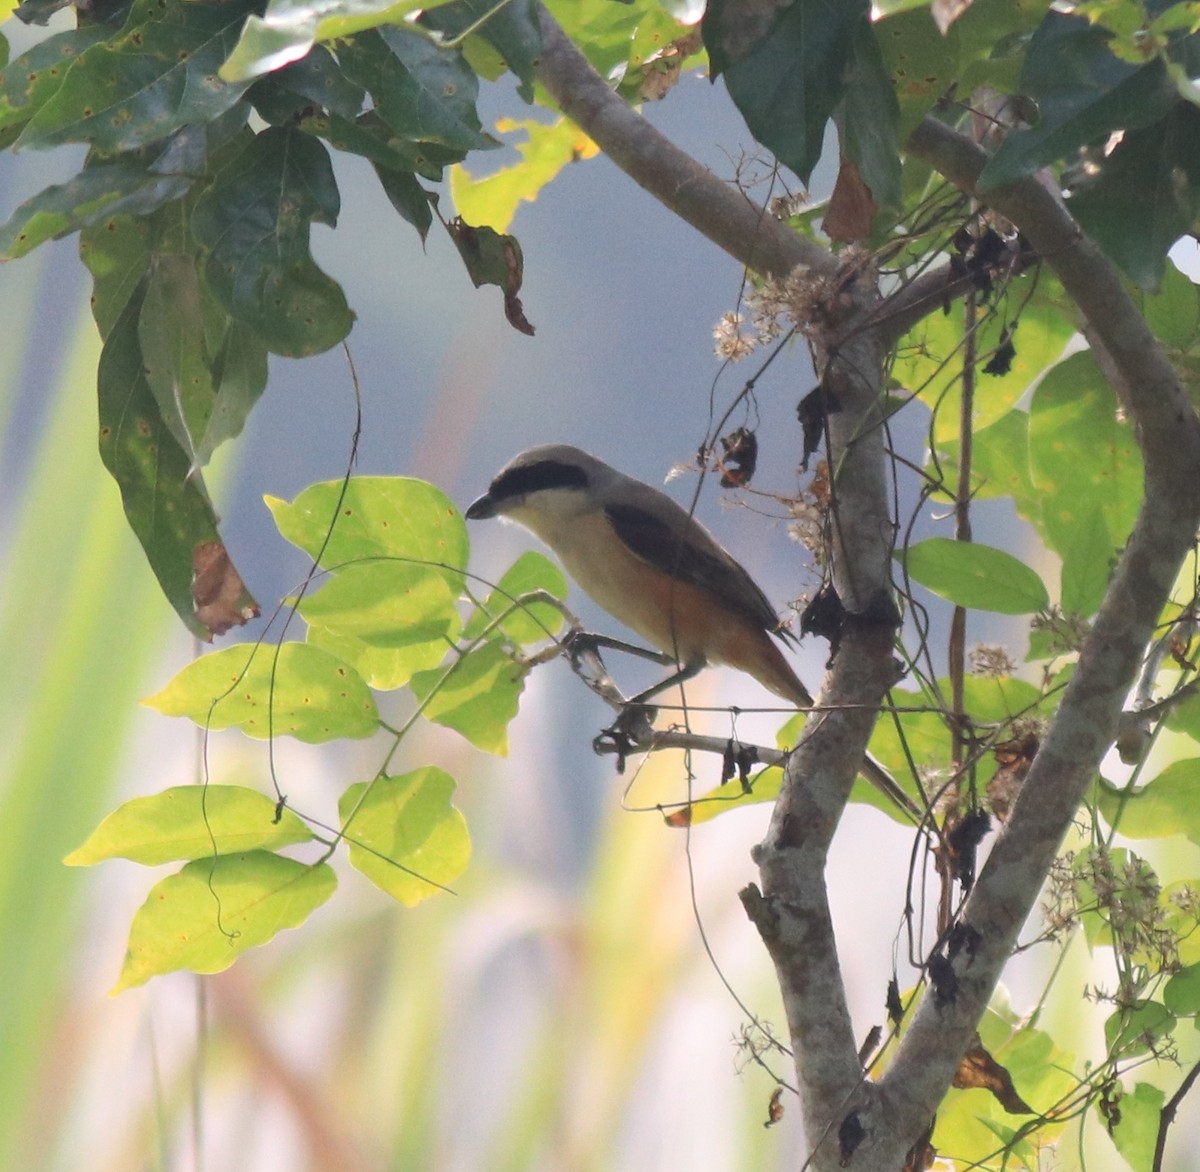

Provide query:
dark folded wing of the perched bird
left=604, top=504, right=790, bottom=637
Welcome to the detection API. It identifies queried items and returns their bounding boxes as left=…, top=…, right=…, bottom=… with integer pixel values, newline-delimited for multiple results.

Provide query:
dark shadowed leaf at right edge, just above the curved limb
left=1069, top=102, right=1200, bottom=293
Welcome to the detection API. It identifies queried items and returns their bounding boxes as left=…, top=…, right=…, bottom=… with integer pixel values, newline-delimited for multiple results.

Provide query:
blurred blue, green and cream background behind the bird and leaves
left=0, top=27, right=1142, bottom=1172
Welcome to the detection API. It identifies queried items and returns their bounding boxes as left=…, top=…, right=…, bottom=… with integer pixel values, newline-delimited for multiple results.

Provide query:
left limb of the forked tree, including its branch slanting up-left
left=540, top=14, right=907, bottom=1170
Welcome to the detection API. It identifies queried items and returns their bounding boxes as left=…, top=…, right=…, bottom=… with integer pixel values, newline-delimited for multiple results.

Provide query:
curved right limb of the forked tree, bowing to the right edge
left=870, top=120, right=1200, bottom=1151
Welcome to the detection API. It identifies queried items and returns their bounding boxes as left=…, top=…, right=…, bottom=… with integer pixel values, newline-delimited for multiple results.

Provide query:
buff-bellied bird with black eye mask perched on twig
left=467, top=444, right=812, bottom=708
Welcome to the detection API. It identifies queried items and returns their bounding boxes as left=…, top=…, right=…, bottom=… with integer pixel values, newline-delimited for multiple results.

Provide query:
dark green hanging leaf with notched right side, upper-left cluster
left=191, top=127, right=354, bottom=357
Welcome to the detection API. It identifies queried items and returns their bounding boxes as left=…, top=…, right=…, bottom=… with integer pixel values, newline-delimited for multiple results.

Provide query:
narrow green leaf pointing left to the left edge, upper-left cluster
left=0, top=163, right=196, bottom=260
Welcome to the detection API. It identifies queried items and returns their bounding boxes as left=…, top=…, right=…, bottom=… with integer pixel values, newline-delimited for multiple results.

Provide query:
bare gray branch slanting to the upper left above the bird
left=538, top=7, right=836, bottom=277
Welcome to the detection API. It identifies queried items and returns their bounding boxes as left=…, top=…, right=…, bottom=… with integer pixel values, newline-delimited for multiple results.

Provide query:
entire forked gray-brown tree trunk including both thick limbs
left=541, top=13, right=1200, bottom=1172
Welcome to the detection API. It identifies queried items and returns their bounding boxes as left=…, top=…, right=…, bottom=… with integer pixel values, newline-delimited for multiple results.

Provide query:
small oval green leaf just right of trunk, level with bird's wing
left=904, top=537, right=1050, bottom=614
